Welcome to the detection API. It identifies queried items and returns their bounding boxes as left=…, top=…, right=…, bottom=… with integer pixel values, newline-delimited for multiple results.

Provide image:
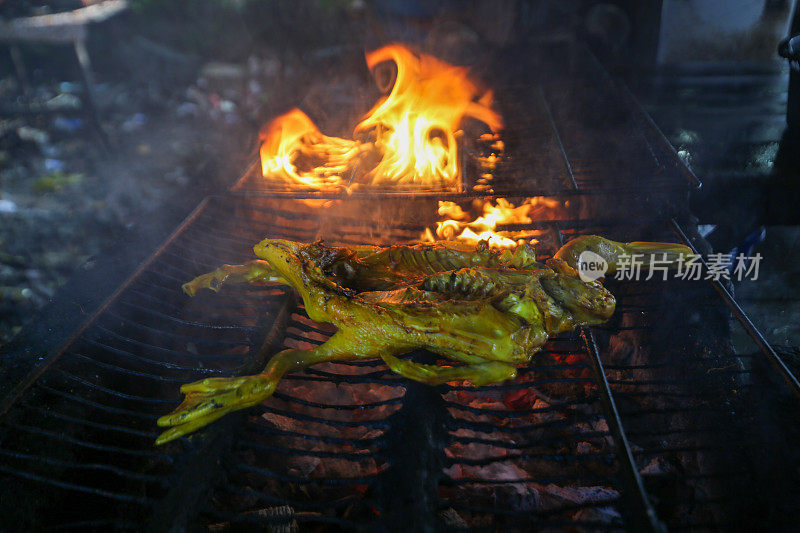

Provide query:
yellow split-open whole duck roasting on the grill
left=156, top=236, right=691, bottom=444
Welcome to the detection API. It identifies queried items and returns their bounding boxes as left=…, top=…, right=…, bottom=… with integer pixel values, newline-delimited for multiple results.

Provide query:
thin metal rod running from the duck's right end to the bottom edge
left=581, top=328, right=666, bottom=532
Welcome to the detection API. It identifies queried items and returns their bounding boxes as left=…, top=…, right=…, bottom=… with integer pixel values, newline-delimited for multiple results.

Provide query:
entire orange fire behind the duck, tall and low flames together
left=261, top=44, right=562, bottom=248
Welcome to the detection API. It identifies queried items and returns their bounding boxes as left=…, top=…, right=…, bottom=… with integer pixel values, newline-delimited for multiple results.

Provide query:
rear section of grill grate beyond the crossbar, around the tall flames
left=233, top=43, right=700, bottom=198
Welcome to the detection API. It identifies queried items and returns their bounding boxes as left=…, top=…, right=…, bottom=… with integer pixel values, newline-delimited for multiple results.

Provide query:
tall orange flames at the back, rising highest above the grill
left=260, top=44, right=503, bottom=190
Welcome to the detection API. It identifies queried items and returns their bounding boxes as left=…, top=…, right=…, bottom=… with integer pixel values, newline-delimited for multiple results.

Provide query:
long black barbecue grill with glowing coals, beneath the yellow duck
left=0, top=39, right=800, bottom=531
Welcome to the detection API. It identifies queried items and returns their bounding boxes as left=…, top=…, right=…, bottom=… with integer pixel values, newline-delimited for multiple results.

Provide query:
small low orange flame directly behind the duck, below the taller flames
left=420, top=196, right=561, bottom=248
